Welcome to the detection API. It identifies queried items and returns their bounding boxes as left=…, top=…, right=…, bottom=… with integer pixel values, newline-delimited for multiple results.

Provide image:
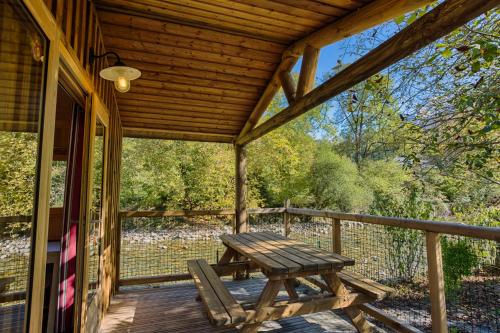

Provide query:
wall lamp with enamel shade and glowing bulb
left=89, top=48, right=141, bottom=93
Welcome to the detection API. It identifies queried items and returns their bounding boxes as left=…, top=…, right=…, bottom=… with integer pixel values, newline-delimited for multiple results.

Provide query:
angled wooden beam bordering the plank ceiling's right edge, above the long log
left=239, top=0, right=434, bottom=137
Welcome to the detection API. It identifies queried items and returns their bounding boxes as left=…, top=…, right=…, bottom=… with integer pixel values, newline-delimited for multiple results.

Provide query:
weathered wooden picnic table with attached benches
left=188, top=232, right=392, bottom=333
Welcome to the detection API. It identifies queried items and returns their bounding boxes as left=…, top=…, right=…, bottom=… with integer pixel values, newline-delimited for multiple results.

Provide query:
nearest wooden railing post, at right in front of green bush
left=425, top=231, right=448, bottom=333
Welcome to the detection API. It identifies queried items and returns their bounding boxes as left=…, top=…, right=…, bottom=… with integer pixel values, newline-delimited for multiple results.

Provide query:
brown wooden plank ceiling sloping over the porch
left=96, top=0, right=370, bottom=142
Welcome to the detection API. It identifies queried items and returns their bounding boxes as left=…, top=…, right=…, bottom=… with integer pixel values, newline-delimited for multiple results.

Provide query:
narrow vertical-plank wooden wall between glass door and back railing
left=44, top=0, right=122, bottom=324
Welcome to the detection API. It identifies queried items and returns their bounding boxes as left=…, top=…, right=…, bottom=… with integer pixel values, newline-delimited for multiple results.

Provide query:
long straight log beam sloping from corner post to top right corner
left=236, top=0, right=500, bottom=144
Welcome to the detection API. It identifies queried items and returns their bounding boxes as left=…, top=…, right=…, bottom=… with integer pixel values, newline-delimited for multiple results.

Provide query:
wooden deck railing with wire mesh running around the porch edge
left=119, top=207, right=500, bottom=332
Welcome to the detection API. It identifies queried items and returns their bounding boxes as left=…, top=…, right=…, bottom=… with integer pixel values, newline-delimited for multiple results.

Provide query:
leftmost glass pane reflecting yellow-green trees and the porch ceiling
left=0, top=0, right=48, bottom=332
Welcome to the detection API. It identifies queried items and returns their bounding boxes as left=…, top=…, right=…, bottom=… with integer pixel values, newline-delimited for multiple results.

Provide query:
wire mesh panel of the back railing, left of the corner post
left=120, top=211, right=233, bottom=280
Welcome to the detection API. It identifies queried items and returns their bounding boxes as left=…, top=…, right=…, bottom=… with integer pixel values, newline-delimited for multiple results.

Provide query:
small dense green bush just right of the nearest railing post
left=441, top=238, right=479, bottom=296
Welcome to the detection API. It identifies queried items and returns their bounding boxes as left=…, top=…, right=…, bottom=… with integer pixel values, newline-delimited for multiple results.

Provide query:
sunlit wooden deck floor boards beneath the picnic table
left=101, top=278, right=382, bottom=333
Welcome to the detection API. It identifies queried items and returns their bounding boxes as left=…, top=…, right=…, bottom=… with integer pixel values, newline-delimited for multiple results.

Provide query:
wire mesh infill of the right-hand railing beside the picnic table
left=289, top=209, right=500, bottom=333
